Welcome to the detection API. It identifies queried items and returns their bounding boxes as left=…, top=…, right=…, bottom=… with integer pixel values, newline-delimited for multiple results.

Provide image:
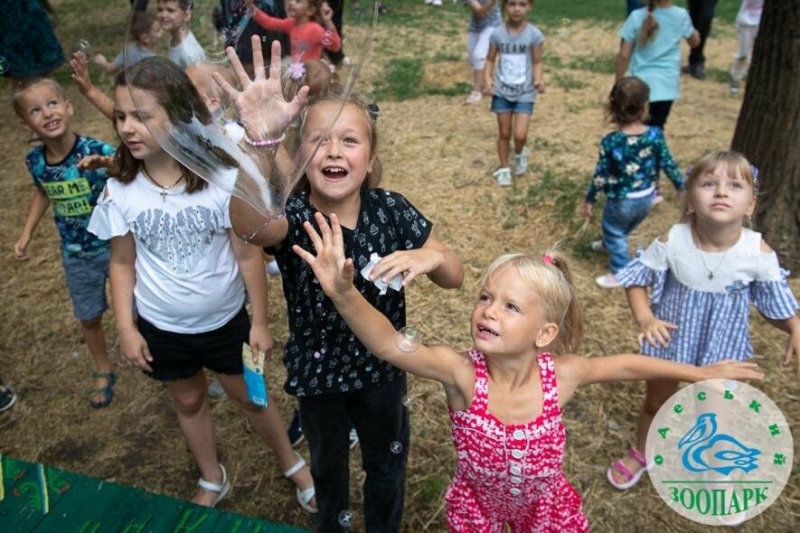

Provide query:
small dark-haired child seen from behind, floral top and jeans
left=581, top=77, right=683, bottom=289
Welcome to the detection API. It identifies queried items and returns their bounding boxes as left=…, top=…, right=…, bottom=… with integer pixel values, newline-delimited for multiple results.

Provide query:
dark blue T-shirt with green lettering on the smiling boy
left=25, top=135, right=115, bottom=258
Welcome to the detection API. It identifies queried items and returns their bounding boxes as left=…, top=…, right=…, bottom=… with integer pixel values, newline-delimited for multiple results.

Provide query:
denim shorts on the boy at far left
left=61, top=250, right=111, bottom=320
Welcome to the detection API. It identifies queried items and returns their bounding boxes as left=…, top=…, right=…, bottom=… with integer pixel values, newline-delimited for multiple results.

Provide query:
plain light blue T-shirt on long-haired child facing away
left=619, top=6, right=694, bottom=102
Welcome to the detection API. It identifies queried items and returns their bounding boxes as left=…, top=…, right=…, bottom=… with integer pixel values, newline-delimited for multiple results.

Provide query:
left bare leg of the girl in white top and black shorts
left=167, top=372, right=222, bottom=506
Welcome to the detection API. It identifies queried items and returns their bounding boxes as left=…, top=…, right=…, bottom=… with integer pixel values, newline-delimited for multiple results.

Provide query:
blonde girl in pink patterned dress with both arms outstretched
left=294, top=214, right=763, bottom=533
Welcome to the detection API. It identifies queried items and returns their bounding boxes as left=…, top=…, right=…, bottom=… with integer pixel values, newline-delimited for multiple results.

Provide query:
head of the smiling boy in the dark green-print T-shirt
left=17, top=82, right=73, bottom=140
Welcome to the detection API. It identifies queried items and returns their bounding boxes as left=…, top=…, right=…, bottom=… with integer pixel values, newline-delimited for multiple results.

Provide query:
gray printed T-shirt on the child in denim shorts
left=489, top=24, right=544, bottom=102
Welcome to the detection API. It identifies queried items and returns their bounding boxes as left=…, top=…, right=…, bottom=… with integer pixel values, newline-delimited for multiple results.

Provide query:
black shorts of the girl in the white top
left=138, top=307, right=250, bottom=381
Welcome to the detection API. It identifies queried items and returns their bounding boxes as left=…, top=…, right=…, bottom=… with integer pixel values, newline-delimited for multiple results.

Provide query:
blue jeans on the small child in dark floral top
left=603, top=196, right=653, bottom=274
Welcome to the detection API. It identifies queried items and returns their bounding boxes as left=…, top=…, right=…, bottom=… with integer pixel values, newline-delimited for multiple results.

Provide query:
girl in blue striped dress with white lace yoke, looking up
left=607, top=151, right=800, bottom=490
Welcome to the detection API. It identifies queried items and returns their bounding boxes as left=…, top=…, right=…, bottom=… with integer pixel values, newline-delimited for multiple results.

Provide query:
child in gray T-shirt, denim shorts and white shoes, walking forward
left=483, top=0, right=544, bottom=187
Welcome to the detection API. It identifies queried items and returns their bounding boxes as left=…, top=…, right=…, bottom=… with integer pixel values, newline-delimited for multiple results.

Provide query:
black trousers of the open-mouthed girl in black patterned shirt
left=298, top=375, right=409, bottom=533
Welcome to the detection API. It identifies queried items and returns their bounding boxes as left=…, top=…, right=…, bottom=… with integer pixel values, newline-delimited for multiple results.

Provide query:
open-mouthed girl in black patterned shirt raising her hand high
left=215, top=39, right=464, bottom=533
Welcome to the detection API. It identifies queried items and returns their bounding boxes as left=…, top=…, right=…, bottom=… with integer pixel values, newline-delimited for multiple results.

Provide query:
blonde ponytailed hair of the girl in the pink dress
left=481, top=245, right=583, bottom=353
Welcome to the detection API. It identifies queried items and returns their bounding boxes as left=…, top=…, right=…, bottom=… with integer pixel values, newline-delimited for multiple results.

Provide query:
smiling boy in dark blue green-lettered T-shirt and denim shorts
left=14, top=78, right=117, bottom=409
